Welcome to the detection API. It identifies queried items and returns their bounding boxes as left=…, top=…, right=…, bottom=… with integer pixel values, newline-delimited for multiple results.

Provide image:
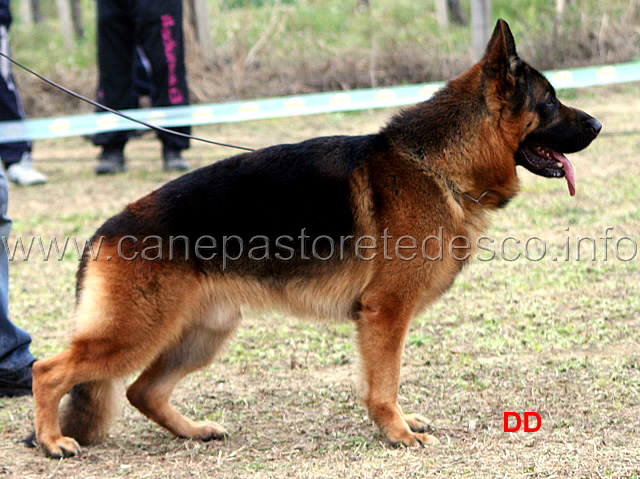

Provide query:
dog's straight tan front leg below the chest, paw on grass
left=357, top=294, right=438, bottom=446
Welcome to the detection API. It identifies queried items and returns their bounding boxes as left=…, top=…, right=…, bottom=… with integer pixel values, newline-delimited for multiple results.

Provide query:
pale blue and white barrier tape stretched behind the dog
left=0, top=61, right=640, bottom=143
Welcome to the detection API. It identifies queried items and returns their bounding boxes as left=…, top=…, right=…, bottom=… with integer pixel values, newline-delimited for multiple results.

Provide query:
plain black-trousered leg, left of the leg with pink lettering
left=93, top=0, right=138, bottom=174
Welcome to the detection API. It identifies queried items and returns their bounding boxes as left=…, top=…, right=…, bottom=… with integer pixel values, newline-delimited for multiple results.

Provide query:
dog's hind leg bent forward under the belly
left=127, top=310, right=241, bottom=441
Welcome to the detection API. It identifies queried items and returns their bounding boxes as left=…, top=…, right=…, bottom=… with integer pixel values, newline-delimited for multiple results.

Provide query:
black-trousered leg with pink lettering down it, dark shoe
left=136, top=0, right=191, bottom=170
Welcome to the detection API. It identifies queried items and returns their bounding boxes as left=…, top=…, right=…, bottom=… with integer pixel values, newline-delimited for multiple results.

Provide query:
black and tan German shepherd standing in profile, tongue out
left=33, top=20, right=602, bottom=457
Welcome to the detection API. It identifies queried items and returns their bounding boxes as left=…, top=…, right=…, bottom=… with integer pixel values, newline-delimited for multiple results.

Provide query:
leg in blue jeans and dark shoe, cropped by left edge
left=0, top=161, right=34, bottom=397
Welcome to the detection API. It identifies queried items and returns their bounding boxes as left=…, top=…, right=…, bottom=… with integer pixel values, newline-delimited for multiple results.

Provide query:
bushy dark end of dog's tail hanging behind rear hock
left=60, top=379, right=122, bottom=445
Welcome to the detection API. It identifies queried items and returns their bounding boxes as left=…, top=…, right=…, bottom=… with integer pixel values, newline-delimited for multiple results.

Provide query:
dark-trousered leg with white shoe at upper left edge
left=0, top=25, right=47, bottom=186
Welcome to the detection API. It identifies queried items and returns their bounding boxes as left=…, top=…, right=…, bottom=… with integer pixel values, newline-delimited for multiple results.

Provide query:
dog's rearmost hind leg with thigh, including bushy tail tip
left=33, top=261, right=201, bottom=457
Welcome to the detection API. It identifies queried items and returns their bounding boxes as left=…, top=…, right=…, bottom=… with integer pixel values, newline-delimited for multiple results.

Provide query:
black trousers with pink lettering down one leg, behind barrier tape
left=93, top=0, right=191, bottom=150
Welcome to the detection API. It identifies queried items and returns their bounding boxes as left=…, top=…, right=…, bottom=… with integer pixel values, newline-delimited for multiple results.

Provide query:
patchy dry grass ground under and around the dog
left=0, top=85, right=640, bottom=478
